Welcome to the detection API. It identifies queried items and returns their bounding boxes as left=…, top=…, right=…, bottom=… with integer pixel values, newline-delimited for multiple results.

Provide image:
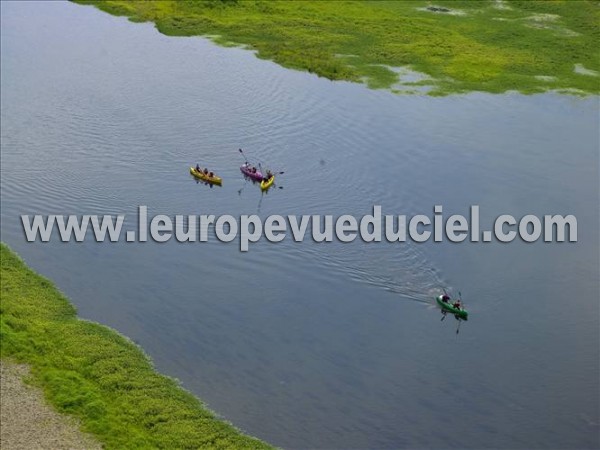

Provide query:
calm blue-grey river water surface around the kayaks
left=1, top=2, right=599, bottom=448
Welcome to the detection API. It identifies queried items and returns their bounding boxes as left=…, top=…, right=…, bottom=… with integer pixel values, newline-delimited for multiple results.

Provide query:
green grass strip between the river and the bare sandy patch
left=0, top=244, right=269, bottom=449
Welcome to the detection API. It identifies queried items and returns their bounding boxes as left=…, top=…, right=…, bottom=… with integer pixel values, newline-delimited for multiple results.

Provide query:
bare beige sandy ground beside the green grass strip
left=0, top=361, right=102, bottom=450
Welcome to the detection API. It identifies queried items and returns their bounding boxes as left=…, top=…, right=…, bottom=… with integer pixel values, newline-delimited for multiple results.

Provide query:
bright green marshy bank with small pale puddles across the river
left=75, top=0, right=600, bottom=95
